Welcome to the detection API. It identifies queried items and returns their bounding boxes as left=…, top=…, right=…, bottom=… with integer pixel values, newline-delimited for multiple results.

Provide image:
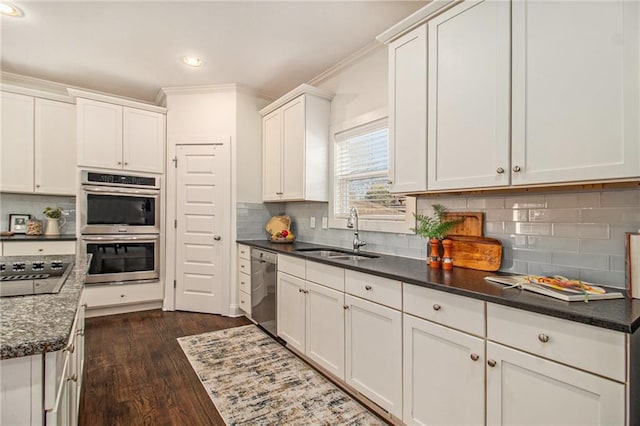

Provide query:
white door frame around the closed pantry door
left=162, top=136, right=236, bottom=316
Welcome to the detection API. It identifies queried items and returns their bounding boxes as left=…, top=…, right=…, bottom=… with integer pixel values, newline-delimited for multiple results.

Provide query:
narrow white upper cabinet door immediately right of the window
left=389, top=21, right=427, bottom=192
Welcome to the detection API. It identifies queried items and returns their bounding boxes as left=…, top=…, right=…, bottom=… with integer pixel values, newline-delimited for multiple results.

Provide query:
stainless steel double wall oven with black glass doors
left=80, top=170, right=161, bottom=283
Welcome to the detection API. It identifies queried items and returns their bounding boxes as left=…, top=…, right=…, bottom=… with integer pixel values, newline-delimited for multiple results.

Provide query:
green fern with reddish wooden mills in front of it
left=411, top=204, right=462, bottom=269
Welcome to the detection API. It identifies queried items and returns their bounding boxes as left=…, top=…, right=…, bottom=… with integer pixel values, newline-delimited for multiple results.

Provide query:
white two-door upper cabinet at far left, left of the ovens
left=0, top=92, right=76, bottom=195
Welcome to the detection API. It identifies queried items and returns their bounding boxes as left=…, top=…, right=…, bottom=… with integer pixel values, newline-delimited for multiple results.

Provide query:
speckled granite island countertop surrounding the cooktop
left=0, top=255, right=91, bottom=359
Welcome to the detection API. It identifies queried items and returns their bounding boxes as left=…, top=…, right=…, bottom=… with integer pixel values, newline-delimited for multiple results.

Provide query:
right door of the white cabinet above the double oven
left=122, top=107, right=165, bottom=173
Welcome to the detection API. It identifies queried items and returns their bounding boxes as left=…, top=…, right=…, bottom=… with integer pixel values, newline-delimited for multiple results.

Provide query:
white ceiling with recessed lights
left=0, top=1, right=427, bottom=102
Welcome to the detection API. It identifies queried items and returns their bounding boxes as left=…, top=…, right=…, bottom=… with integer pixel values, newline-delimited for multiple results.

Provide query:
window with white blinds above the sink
left=332, top=118, right=407, bottom=221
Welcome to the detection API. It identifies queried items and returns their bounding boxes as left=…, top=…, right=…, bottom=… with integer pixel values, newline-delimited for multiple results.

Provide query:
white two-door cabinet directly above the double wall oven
left=78, top=98, right=165, bottom=173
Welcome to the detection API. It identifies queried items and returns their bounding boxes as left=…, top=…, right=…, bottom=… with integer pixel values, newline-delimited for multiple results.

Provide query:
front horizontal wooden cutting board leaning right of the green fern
left=448, top=236, right=502, bottom=271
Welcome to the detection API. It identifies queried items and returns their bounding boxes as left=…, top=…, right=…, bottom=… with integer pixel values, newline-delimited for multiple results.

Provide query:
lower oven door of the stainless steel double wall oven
left=82, top=235, right=160, bottom=283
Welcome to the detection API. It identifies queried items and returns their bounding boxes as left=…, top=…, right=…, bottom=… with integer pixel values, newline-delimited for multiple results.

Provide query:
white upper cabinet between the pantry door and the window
left=260, top=85, right=332, bottom=201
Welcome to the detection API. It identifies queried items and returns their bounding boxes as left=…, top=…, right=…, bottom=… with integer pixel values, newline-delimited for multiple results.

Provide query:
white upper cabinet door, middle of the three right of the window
left=428, top=0, right=511, bottom=190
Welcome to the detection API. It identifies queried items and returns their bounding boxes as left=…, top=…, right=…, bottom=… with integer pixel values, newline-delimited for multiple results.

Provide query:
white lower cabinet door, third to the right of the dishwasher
left=345, top=295, right=402, bottom=417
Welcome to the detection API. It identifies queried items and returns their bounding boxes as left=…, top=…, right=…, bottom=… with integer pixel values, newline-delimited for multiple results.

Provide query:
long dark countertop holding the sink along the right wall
left=237, top=240, right=640, bottom=333
